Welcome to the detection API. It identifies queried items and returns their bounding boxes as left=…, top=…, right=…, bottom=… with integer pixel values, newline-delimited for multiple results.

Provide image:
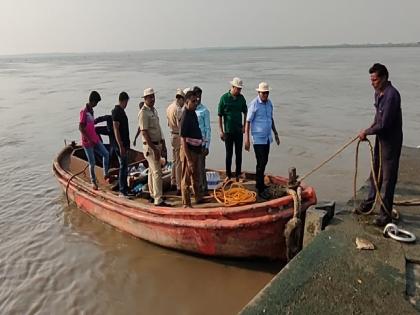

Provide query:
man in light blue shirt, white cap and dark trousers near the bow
left=245, top=82, right=280, bottom=199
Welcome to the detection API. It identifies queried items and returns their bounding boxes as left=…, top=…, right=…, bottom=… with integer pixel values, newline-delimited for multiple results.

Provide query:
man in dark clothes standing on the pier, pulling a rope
left=357, top=63, right=403, bottom=227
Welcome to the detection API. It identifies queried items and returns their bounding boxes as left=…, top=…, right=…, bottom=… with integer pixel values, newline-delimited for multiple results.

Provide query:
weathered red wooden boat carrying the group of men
left=53, top=145, right=316, bottom=261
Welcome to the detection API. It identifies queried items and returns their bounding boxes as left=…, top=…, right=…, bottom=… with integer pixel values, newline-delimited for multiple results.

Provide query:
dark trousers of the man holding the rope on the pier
left=363, top=135, right=402, bottom=220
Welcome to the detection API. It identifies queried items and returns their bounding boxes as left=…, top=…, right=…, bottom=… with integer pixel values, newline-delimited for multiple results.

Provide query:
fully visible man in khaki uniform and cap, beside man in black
left=139, top=88, right=170, bottom=206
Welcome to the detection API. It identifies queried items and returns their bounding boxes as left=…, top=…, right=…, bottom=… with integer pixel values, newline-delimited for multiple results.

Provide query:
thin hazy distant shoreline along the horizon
left=0, top=42, right=420, bottom=58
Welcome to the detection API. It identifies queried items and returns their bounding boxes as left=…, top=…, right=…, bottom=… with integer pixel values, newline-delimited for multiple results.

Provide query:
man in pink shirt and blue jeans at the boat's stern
left=79, top=91, right=109, bottom=190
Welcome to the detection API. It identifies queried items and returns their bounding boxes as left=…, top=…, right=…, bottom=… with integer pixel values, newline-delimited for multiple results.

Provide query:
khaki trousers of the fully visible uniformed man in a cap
left=143, top=145, right=163, bottom=205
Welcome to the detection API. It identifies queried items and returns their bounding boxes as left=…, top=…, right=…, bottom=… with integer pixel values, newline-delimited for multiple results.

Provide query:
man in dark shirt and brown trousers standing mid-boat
left=179, top=91, right=203, bottom=207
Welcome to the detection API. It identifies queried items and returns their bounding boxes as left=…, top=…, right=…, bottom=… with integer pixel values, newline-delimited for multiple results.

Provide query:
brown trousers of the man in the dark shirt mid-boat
left=181, top=146, right=201, bottom=207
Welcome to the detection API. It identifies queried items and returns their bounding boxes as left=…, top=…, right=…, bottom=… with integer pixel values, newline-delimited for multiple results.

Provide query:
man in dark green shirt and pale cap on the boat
left=218, top=78, right=248, bottom=181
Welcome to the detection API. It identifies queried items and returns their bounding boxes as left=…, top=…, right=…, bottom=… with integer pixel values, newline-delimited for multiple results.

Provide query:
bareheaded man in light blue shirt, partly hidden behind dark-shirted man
left=193, top=86, right=211, bottom=194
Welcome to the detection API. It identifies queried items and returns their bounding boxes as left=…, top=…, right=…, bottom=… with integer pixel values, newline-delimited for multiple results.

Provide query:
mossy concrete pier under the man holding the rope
left=241, top=147, right=420, bottom=315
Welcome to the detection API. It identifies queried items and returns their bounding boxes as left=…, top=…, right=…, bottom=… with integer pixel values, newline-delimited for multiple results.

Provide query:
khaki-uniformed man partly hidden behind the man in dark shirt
left=166, top=89, right=185, bottom=196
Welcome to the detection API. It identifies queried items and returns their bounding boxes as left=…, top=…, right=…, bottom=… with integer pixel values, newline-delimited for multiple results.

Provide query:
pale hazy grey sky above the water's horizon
left=0, top=0, right=420, bottom=54
